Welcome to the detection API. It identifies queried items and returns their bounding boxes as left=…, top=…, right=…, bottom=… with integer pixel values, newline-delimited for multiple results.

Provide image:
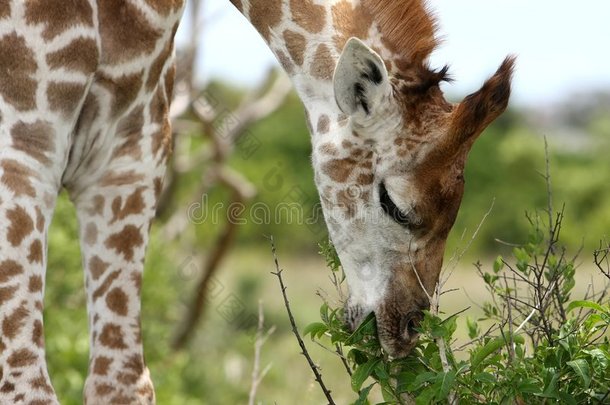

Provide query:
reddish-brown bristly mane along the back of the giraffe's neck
left=362, top=0, right=438, bottom=65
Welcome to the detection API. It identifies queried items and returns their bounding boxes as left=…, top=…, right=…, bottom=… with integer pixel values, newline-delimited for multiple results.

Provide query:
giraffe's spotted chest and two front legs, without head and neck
left=0, top=0, right=182, bottom=404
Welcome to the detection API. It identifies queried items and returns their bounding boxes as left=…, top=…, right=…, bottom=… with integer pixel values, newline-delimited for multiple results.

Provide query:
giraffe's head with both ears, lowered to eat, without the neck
left=314, top=38, right=514, bottom=357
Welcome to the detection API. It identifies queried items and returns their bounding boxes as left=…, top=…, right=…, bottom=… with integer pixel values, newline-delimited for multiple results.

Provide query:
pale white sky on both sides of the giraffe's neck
left=178, top=0, right=610, bottom=106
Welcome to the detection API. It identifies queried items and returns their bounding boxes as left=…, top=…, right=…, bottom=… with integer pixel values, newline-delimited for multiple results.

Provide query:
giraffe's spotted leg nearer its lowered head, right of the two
left=75, top=179, right=162, bottom=405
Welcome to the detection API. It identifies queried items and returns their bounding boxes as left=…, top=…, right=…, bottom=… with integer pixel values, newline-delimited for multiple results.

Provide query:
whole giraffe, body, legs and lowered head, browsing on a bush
left=0, top=0, right=513, bottom=404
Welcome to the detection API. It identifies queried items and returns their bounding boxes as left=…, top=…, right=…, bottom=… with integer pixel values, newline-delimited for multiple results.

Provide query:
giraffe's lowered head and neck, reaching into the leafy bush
left=231, top=0, right=515, bottom=357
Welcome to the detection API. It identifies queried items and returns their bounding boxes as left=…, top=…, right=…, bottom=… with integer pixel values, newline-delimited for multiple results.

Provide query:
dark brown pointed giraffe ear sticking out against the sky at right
left=450, top=56, right=515, bottom=144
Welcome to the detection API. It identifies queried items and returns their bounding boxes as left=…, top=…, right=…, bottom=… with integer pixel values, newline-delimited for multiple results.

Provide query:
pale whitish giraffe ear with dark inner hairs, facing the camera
left=333, top=38, right=392, bottom=117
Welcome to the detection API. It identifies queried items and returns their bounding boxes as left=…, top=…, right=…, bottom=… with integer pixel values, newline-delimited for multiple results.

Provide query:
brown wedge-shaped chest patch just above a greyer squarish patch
left=47, top=37, right=100, bottom=74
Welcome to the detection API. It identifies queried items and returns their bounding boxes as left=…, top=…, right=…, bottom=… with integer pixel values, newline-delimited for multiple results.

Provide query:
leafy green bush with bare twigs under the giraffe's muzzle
left=305, top=208, right=610, bottom=404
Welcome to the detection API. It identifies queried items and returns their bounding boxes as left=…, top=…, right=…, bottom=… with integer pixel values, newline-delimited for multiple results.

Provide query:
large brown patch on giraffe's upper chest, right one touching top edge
left=97, top=0, right=162, bottom=64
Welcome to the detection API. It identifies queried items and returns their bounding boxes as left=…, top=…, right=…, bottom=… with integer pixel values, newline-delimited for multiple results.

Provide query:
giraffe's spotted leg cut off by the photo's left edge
left=0, top=156, right=59, bottom=404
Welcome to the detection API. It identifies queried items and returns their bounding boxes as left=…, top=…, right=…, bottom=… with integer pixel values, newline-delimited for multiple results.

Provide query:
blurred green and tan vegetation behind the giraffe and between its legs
left=45, top=2, right=610, bottom=405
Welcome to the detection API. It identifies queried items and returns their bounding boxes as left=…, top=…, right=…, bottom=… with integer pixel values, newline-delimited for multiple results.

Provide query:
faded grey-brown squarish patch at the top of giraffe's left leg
left=11, top=120, right=55, bottom=166
